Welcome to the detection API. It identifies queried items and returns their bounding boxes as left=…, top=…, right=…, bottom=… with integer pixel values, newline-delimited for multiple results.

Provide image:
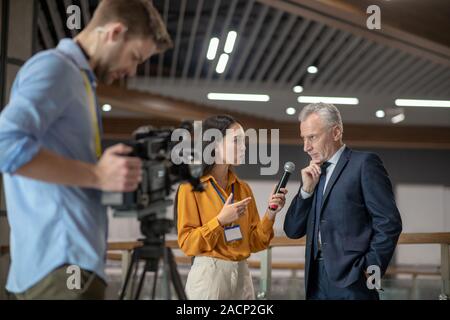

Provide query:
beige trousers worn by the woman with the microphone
left=186, top=257, right=255, bottom=300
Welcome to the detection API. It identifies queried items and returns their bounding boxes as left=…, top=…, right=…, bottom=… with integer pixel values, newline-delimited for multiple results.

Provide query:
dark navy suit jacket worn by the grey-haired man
left=284, top=148, right=402, bottom=292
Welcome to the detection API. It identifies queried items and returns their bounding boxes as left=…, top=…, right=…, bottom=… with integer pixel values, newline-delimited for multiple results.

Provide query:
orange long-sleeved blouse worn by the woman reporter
left=177, top=171, right=274, bottom=261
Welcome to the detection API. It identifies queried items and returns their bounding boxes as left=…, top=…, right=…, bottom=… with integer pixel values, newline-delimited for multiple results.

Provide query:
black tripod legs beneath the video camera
left=120, top=230, right=187, bottom=300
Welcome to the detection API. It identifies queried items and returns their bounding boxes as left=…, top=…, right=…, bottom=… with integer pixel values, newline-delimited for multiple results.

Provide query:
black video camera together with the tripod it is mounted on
left=106, top=121, right=203, bottom=300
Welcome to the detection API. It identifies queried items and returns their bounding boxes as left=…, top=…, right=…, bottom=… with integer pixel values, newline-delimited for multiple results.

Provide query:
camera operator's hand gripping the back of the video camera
left=95, top=144, right=142, bottom=192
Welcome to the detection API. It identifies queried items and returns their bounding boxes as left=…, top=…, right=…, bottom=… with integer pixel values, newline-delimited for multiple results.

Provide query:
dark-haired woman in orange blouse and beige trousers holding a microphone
left=177, top=115, right=287, bottom=300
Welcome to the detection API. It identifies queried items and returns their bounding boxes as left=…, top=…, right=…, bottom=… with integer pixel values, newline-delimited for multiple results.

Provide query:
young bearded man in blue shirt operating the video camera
left=0, top=0, right=172, bottom=299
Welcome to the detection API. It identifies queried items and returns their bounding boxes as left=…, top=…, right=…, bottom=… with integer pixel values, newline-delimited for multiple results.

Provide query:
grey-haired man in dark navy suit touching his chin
left=284, top=103, right=402, bottom=300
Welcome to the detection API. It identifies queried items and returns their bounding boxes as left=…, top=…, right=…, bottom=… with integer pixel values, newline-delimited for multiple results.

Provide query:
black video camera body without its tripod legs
left=102, top=122, right=203, bottom=238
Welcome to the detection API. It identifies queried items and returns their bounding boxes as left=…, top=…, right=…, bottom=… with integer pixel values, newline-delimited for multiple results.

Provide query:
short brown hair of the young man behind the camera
left=88, top=0, right=173, bottom=52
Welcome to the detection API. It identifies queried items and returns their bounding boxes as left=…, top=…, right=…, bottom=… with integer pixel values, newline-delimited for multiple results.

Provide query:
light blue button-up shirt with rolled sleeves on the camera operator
left=0, top=39, right=108, bottom=293
